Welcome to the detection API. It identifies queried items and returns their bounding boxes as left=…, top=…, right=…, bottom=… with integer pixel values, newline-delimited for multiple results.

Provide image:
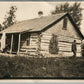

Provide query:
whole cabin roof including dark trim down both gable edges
left=0, top=13, right=83, bottom=38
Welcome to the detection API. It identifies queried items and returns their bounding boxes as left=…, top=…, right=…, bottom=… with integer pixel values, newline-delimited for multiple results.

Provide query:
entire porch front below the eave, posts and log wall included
left=1, top=32, right=38, bottom=56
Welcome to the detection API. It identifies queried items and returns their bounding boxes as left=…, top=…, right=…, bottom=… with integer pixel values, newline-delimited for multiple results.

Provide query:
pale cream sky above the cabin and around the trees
left=0, top=1, right=84, bottom=34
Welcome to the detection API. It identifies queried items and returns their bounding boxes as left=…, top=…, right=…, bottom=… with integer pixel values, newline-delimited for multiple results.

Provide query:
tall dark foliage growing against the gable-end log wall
left=49, top=34, right=58, bottom=54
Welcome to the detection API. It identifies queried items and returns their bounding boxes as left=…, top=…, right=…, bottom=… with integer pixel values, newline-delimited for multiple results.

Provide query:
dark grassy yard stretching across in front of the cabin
left=0, top=56, right=84, bottom=78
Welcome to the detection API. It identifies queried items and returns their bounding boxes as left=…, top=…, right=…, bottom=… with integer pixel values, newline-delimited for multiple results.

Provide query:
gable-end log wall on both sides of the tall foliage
left=41, top=33, right=81, bottom=56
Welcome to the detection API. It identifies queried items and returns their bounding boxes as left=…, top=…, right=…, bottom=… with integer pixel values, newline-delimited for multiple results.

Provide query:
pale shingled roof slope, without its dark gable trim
left=1, top=13, right=65, bottom=33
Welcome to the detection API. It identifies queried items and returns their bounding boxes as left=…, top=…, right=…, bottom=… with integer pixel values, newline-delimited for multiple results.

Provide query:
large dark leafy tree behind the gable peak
left=52, top=2, right=82, bottom=29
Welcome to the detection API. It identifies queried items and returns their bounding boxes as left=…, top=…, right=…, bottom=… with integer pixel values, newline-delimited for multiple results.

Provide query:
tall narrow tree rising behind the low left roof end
left=3, top=6, right=17, bottom=29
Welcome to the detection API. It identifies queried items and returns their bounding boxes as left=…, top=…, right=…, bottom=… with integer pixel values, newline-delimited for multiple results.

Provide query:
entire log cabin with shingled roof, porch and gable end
left=0, top=13, right=83, bottom=56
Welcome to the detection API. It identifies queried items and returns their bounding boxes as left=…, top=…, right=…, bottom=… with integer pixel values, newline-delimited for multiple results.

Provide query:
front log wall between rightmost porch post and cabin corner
left=20, top=33, right=38, bottom=55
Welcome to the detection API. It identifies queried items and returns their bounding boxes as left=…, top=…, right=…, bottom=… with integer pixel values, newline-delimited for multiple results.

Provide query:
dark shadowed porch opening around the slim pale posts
left=3, top=33, right=21, bottom=54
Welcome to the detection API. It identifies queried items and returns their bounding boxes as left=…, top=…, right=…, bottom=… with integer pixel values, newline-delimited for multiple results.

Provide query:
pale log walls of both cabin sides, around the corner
left=20, top=33, right=81, bottom=56
